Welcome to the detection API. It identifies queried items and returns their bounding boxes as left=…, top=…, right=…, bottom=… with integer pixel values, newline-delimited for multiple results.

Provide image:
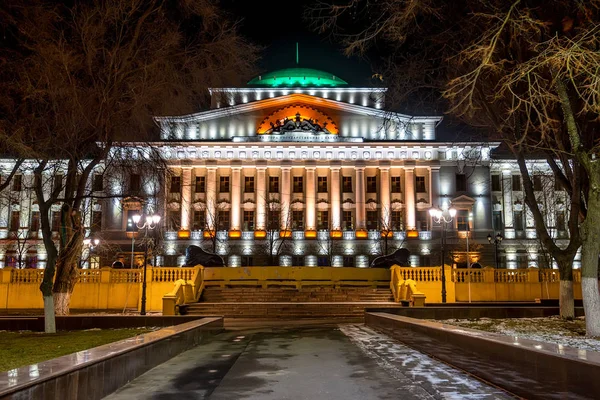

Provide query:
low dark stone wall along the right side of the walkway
left=365, top=312, right=600, bottom=400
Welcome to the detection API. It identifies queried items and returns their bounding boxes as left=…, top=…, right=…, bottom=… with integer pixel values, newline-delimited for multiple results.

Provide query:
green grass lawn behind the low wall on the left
left=0, top=328, right=152, bottom=371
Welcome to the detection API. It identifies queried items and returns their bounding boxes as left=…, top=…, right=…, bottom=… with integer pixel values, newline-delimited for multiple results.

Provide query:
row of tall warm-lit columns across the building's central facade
left=181, top=166, right=439, bottom=230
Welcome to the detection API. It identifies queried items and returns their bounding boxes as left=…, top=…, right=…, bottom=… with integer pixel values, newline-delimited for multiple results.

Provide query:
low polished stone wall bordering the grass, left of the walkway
left=0, top=318, right=223, bottom=400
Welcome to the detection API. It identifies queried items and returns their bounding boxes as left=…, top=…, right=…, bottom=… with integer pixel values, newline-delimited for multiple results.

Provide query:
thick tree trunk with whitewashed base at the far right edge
left=581, top=188, right=600, bottom=337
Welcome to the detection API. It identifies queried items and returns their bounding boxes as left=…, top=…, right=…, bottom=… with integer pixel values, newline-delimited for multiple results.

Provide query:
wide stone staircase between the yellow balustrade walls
left=187, top=287, right=400, bottom=320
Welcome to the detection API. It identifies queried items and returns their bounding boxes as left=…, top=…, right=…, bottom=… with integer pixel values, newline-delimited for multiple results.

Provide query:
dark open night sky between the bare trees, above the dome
left=221, top=0, right=372, bottom=86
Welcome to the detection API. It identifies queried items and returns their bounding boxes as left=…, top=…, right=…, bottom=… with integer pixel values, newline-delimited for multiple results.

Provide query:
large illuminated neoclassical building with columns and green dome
left=0, top=68, right=565, bottom=268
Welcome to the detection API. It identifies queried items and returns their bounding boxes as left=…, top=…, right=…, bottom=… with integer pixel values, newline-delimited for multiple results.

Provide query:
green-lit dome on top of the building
left=248, top=68, right=348, bottom=87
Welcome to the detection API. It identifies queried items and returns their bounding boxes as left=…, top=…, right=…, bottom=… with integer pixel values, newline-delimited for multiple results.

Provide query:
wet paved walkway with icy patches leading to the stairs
left=106, top=324, right=512, bottom=400
